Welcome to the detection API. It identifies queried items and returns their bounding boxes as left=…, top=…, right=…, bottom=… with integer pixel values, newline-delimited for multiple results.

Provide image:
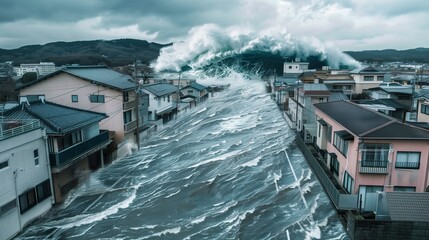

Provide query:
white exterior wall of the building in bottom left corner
left=0, top=129, right=52, bottom=239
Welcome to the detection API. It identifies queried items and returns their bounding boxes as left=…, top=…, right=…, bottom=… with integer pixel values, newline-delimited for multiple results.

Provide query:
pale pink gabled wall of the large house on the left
left=20, top=73, right=132, bottom=148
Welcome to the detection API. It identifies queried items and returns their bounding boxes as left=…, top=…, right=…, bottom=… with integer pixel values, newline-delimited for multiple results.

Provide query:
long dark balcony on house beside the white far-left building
left=49, top=130, right=110, bottom=168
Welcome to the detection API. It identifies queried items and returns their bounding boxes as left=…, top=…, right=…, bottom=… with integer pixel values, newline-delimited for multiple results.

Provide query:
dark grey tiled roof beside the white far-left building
left=5, top=102, right=107, bottom=134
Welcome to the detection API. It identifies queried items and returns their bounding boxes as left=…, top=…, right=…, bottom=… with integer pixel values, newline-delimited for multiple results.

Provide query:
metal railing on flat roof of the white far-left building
left=0, top=119, right=40, bottom=141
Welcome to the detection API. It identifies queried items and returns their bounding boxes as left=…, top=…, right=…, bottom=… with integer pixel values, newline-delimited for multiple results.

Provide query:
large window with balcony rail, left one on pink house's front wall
left=361, top=144, right=390, bottom=167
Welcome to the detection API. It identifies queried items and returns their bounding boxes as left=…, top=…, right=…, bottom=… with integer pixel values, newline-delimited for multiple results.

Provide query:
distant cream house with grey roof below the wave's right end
left=350, top=67, right=385, bottom=94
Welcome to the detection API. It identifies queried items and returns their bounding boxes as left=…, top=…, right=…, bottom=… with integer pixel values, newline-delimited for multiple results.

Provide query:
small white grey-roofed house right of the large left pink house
left=141, top=83, right=179, bottom=123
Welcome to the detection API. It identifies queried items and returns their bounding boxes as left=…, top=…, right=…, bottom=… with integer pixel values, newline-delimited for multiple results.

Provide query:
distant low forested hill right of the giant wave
left=345, top=48, right=429, bottom=63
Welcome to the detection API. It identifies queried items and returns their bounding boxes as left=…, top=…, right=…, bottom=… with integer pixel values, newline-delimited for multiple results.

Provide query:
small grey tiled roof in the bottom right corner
left=386, top=192, right=429, bottom=222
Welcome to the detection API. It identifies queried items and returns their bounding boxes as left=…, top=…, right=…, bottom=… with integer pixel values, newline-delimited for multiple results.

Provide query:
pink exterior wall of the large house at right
left=316, top=109, right=429, bottom=194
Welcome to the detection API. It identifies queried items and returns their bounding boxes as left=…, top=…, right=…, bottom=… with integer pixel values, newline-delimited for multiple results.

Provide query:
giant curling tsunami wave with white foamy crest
left=152, top=24, right=360, bottom=73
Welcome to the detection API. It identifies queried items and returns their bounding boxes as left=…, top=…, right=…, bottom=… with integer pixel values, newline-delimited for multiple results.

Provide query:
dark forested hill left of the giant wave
left=0, top=39, right=169, bottom=67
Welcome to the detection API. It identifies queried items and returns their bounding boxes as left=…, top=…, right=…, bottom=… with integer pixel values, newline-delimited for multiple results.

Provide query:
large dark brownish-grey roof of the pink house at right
left=314, top=101, right=429, bottom=140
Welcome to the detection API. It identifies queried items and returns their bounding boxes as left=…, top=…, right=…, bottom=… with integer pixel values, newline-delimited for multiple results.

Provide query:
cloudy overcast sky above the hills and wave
left=0, top=0, right=429, bottom=51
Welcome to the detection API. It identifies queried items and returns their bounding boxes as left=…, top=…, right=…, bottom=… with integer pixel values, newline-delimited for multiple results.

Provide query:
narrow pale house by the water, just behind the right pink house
left=288, top=83, right=331, bottom=142
